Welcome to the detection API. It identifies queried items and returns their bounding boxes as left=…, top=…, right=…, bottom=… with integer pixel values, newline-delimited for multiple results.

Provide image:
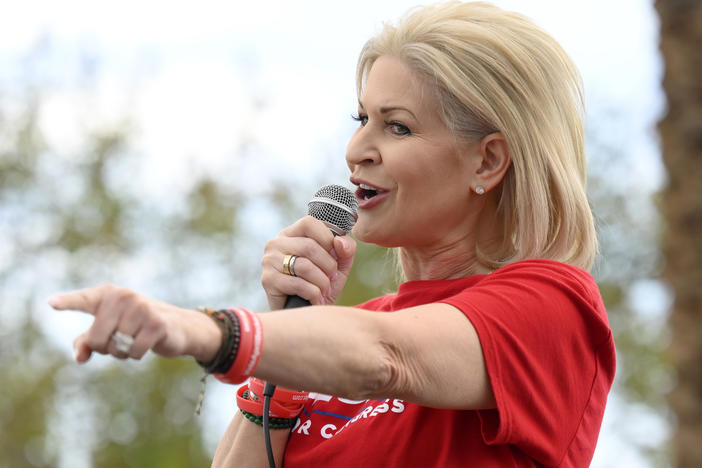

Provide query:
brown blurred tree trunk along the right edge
left=656, top=0, right=702, bottom=468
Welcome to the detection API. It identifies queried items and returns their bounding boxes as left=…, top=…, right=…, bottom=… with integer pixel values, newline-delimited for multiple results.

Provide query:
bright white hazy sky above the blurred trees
left=0, top=0, right=665, bottom=468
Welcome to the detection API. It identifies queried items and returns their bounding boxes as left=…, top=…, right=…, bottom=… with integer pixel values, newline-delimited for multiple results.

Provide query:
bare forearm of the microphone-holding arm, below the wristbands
left=212, top=412, right=290, bottom=468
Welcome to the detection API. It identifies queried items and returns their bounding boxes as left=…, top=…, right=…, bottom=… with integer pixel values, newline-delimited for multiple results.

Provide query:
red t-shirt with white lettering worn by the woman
left=284, top=260, right=615, bottom=468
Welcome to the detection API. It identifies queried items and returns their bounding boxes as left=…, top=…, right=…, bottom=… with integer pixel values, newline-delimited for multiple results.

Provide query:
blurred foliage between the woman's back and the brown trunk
left=588, top=121, right=674, bottom=467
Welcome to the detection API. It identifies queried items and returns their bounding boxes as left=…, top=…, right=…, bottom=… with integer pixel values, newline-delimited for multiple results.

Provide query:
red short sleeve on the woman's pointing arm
left=441, top=260, right=615, bottom=466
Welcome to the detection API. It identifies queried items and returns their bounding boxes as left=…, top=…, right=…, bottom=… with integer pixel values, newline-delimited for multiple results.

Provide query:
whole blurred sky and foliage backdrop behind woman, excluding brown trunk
left=0, top=0, right=692, bottom=468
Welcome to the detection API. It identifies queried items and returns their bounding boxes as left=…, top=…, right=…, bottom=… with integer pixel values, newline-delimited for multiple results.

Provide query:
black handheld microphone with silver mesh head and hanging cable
left=263, top=184, right=358, bottom=468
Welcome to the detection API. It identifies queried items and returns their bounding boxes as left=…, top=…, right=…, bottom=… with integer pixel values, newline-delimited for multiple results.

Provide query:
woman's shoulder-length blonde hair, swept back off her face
left=357, top=2, right=597, bottom=269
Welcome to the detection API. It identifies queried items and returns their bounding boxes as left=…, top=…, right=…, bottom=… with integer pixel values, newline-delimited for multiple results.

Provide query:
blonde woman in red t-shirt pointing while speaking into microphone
left=51, top=3, right=615, bottom=467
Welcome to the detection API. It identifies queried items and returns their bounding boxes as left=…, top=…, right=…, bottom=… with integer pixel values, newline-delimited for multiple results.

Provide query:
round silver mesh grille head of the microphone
left=307, top=184, right=358, bottom=235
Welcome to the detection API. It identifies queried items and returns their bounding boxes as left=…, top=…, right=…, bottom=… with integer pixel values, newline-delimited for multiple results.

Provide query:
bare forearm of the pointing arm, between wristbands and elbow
left=255, top=306, right=390, bottom=399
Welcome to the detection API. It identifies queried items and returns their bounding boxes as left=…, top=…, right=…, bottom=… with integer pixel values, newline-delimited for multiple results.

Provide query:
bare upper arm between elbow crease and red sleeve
left=376, top=303, right=495, bottom=409
